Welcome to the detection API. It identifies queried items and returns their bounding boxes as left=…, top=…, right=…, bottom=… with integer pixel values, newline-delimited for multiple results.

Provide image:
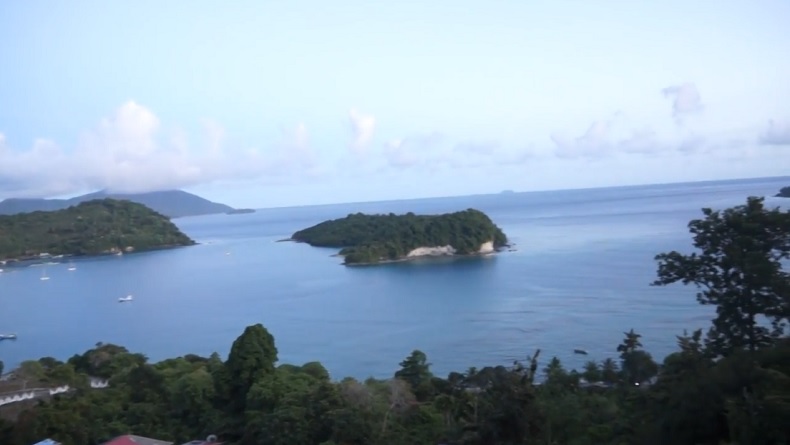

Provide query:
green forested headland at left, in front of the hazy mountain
left=0, top=199, right=194, bottom=259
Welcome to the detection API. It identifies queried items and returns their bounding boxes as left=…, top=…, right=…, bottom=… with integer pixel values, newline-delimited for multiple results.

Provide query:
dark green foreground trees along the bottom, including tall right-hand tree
left=0, top=198, right=790, bottom=445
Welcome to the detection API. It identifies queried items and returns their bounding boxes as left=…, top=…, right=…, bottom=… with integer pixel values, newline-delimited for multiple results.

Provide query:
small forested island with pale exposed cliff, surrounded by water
left=291, top=209, right=507, bottom=265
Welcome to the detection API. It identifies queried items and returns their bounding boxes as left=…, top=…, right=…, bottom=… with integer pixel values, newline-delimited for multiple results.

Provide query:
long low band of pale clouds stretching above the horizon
left=0, top=83, right=790, bottom=198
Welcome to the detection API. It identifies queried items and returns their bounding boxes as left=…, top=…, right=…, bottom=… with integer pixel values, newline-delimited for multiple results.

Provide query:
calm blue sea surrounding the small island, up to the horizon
left=0, top=178, right=790, bottom=378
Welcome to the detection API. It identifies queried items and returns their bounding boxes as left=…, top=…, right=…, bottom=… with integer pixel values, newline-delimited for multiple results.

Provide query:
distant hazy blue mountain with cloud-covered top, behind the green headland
left=0, top=190, right=234, bottom=218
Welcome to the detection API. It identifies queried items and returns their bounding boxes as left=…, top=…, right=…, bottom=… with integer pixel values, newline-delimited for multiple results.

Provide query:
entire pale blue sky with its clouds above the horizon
left=0, top=0, right=790, bottom=208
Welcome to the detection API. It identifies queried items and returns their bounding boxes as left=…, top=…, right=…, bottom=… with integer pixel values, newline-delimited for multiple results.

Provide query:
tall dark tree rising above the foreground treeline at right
left=653, top=197, right=790, bottom=355
